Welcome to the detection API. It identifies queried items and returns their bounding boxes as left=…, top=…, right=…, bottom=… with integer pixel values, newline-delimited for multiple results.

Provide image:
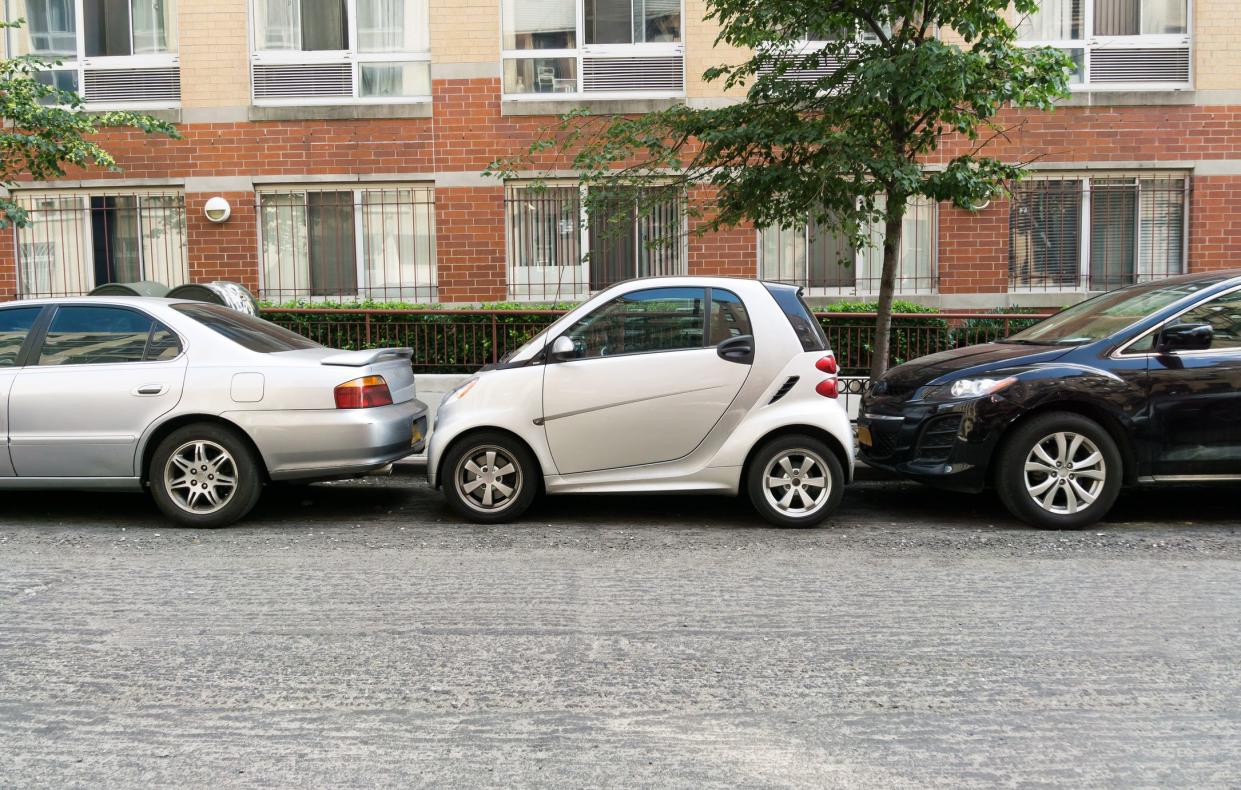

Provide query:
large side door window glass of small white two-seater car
left=566, top=288, right=706, bottom=358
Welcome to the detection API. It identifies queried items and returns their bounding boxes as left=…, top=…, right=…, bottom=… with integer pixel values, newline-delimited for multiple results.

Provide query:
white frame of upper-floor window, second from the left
left=248, top=0, right=431, bottom=107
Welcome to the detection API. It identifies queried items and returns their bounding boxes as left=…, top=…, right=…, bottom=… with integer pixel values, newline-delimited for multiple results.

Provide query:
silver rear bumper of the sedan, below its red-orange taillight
left=221, top=399, right=428, bottom=480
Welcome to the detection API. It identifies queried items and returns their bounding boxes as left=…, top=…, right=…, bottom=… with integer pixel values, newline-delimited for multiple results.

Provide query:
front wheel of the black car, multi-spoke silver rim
left=995, top=412, right=1124, bottom=530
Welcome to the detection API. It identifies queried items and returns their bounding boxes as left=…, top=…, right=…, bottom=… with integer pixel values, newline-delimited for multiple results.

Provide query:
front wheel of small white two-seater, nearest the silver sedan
left=442, top=432, right=539, bottom=523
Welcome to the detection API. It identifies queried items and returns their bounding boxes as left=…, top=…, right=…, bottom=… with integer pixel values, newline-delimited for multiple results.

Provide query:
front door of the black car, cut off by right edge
left=1148, top=291, right=1241, bottom=476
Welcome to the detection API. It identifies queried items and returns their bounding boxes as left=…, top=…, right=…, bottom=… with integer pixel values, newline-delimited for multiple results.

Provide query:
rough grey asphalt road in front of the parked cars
left=0, top=477, right=1241, bottom=788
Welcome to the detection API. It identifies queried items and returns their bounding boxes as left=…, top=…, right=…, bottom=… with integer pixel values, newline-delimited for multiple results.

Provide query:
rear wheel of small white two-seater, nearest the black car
left=746, top=434, right=845, bottom=527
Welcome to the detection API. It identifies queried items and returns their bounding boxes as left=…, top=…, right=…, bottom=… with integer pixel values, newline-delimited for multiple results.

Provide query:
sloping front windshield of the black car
left=1004, top=280, right=1217, bottom=346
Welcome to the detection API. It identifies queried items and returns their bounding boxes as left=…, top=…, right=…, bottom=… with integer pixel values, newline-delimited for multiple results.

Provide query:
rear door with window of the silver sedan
left=9, top=305, right=186, bottom=477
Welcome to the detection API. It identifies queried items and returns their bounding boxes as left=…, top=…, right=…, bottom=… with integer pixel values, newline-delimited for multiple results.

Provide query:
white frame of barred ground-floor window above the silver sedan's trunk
left=254, top=181, right=439, bottom=303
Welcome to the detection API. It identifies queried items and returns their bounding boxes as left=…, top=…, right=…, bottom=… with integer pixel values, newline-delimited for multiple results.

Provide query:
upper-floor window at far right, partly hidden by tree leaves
left=1018, top=0, right=1193, bottom=91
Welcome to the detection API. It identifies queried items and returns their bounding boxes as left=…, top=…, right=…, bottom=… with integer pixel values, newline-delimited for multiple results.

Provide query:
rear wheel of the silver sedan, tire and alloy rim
left=146, top=423, right=263, bottom=528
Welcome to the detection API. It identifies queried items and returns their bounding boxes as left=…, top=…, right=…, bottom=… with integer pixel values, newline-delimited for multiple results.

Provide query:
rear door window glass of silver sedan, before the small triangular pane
left=38, top=306, right=155, bottom=365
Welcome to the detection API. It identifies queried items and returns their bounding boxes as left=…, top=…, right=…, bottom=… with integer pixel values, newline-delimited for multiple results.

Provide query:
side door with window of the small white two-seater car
left=544, top=288, right=753, bottom=474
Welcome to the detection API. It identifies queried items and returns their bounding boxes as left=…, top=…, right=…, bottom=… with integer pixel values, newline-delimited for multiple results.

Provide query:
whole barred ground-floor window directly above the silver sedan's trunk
left=259, top=186, right=436, bottom=301
